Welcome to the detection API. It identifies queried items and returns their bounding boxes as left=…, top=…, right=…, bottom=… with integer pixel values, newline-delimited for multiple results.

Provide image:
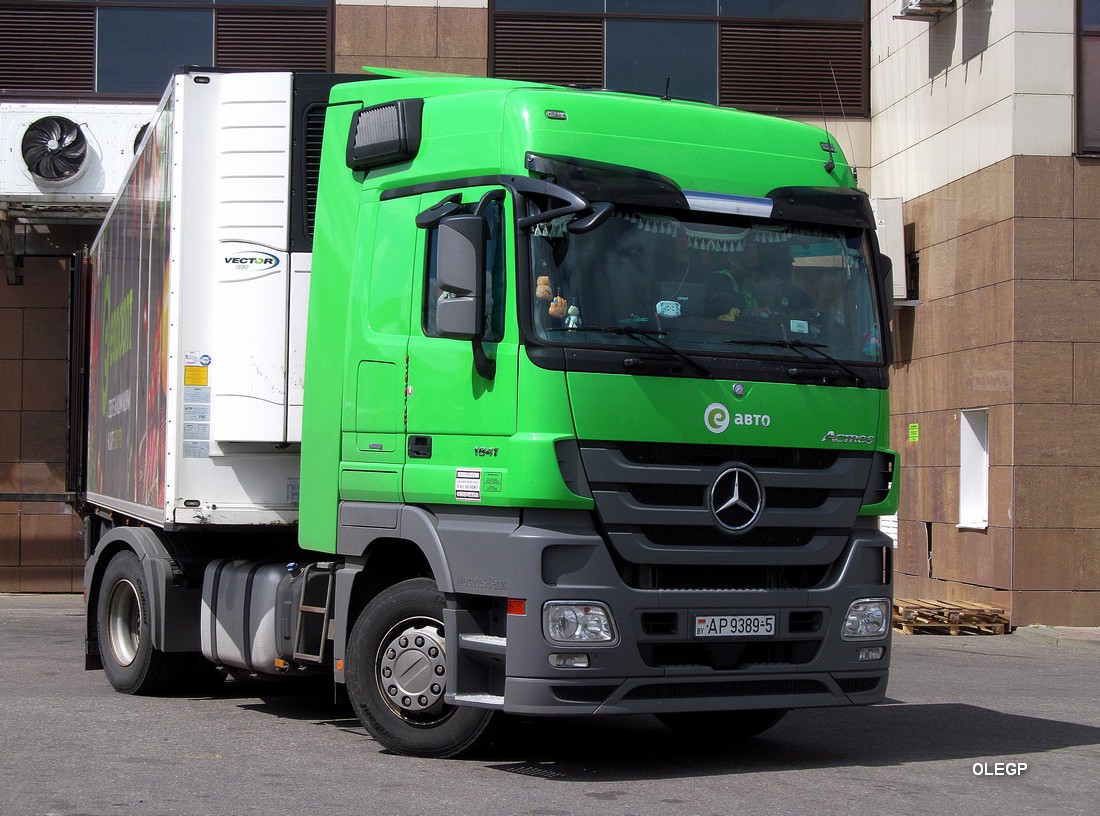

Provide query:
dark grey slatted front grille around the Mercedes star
left=579, top=441, right=873, bottom=576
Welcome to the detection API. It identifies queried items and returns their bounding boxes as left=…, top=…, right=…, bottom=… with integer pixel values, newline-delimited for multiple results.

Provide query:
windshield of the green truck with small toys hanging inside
left=530, top=207, right=883, bottom=364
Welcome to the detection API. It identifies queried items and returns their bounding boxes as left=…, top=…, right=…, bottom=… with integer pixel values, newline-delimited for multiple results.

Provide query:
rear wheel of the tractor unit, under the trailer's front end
left=96, top=550, right=191, bottom=694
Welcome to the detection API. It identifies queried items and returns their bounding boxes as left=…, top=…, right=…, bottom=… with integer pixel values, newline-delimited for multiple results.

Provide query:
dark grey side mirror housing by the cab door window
left=436, top=216, right=486, bottom=340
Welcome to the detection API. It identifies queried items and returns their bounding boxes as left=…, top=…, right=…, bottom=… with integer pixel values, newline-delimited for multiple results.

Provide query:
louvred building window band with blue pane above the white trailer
left=0, top=0, right=333, bottom=99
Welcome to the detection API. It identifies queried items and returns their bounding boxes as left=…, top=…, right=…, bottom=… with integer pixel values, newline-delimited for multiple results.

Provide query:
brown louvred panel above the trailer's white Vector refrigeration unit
left=215, top=9, right=329, bottom=70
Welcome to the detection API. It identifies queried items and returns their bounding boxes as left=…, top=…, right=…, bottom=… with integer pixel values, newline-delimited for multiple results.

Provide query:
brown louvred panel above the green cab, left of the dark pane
left=491, top=18, right=604, bottom=88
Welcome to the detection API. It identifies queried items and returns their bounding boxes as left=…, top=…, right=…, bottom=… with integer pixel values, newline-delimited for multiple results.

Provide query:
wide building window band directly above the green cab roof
left=490, top=0, right=866, bottom=117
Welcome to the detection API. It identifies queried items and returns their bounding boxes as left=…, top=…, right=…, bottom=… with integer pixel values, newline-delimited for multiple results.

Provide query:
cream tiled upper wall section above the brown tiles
left=869, top=0, right=1076, bottom=203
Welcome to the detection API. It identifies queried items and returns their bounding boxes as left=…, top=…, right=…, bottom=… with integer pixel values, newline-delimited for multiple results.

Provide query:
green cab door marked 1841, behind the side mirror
left=404, top=187, right=519, bottom=506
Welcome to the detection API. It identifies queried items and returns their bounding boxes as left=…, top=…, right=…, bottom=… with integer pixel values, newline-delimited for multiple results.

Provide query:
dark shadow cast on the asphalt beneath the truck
left=215, top=679, right=1100, bottom=782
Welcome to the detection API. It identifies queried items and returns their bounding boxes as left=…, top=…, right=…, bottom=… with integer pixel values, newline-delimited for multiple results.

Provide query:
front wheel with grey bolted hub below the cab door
left=344, top=578, right=495, bottom=758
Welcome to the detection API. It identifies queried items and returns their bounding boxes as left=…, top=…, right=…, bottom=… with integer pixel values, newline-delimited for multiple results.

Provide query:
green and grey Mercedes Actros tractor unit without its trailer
left=87, top=71, right=898, bottom=757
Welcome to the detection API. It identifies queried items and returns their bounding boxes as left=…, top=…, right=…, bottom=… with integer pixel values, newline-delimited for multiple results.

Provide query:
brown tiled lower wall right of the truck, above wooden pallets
left=892, top=156, right=1100, bottom=626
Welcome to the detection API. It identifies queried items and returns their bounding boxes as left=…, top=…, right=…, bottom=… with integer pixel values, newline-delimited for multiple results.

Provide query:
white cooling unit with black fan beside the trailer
left=0, top=102, right=156, bottom=212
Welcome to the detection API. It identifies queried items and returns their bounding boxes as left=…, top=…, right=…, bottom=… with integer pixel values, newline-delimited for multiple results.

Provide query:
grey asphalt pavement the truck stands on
left=0, top=595, right=1100, bottom=816
